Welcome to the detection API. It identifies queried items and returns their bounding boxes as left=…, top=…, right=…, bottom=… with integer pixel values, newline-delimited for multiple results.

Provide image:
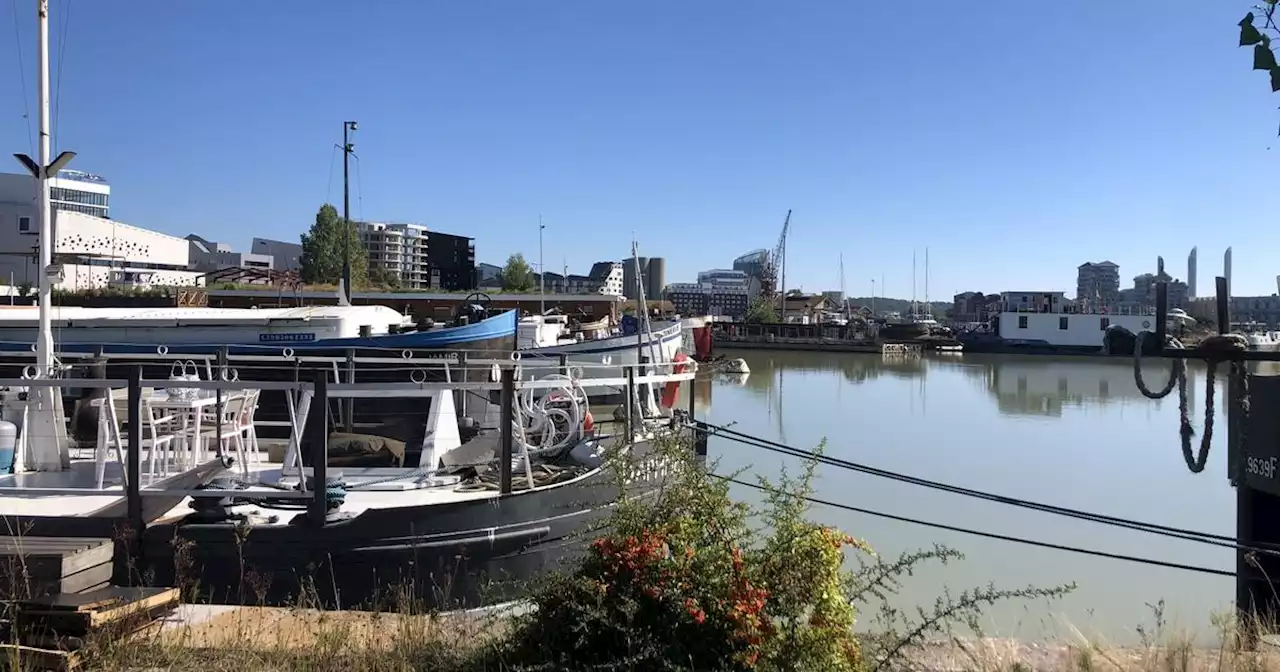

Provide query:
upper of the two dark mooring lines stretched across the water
left=694, top=422, right=1280, bottom=556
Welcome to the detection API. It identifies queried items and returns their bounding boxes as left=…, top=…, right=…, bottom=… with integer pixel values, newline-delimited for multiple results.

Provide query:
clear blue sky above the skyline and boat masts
left=0, top=0, right=1280, bottom=298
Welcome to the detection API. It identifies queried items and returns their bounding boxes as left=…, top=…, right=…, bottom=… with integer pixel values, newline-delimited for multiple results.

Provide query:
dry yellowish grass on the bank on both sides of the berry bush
left=24, top=599, right=1280, bottom=672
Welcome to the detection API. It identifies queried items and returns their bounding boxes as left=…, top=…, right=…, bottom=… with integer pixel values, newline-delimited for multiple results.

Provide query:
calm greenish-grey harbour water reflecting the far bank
left=698, top=351, right=1235, bottom=641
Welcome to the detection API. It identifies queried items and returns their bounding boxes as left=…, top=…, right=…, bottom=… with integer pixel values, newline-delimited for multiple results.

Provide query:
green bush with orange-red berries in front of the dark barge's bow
left=507, top=439, right=1073, bottom=671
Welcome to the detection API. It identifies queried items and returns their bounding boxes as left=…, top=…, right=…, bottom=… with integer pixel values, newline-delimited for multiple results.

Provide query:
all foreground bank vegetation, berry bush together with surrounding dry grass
left=15, top=432, right=1264, bottom=672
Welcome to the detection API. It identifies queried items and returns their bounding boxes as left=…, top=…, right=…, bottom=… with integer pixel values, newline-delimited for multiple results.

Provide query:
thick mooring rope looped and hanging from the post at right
left=1133, top=332, right=1249, bottom=474
